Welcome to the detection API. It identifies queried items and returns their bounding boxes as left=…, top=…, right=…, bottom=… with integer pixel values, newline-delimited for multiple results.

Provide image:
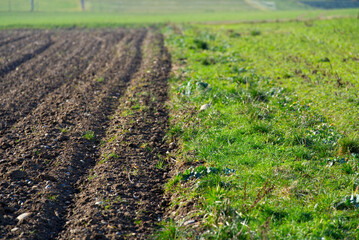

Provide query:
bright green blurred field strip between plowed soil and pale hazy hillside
left=0, top=9, right=358, bottom=28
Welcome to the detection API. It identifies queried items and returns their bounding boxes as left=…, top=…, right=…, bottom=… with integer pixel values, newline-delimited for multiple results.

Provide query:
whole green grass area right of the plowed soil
left=156, top=16, right=359, bottom=239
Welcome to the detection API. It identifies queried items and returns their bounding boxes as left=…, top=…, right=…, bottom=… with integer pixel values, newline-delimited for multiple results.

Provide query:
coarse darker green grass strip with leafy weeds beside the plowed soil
left=155, top=20, right=359, bottom=239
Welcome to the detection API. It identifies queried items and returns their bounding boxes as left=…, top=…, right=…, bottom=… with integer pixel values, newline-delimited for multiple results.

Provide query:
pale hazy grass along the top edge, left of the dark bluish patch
left=0, top=0, right=296, bottom=13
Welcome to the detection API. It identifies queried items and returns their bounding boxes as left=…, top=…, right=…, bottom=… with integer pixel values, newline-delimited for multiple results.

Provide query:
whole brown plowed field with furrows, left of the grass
left=0, top=29, right=171, bottom=239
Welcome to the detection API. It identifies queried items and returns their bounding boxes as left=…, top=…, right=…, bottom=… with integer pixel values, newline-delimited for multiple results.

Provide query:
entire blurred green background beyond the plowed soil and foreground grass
left=0, top=0, right=359, bottom=28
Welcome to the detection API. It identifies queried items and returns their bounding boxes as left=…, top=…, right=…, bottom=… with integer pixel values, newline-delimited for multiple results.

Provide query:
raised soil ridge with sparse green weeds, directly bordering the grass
left=59, top=30, right=170, bottom=239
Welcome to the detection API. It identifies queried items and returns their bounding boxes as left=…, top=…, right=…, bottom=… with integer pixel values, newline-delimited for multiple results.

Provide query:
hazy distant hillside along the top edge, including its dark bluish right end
left=0, top=0, right=359, bottom=13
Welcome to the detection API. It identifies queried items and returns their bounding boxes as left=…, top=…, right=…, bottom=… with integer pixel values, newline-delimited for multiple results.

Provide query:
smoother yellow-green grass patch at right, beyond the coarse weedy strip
left=215, top=19, right=359, bottom=133
